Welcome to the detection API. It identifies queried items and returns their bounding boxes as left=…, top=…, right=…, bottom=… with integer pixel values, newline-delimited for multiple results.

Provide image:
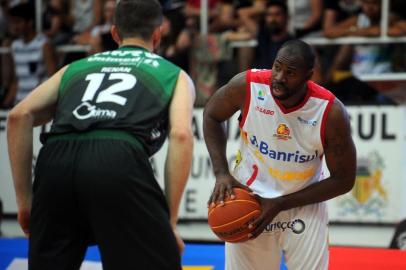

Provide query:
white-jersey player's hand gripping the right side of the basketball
left=248, top=195, right=281, bottom=239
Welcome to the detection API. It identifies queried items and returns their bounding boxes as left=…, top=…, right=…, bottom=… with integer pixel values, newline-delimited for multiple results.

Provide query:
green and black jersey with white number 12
left=48, top=46, right=180, bottom=155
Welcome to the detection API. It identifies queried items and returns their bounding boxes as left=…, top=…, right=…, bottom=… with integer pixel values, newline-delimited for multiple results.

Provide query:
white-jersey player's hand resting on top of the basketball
left=207, top=174, right=252, bottom=207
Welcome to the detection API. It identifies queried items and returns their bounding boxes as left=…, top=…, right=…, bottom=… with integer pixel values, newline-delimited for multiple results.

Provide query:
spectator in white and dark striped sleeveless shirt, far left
left=3, top=3, right=56, bottom=107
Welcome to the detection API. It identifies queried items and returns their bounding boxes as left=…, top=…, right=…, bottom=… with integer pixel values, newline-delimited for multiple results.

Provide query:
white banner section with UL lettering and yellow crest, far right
left=329, top=107, right=406, bottom=223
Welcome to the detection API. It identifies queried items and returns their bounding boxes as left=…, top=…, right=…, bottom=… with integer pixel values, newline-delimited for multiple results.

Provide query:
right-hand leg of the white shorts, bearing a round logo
left=281, top=203, right=329, bottom=270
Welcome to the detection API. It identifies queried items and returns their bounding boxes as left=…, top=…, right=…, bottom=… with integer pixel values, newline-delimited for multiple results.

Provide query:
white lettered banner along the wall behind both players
left=0, top=106, right=406, bottom=223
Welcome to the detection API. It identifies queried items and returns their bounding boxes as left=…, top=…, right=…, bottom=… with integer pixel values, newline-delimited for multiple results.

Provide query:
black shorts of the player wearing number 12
left=29, top=139, right=181, bottom=270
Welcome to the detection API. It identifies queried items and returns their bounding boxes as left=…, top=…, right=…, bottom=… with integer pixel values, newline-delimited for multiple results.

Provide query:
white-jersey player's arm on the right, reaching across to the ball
left=251, top=99, right=356, bottom=238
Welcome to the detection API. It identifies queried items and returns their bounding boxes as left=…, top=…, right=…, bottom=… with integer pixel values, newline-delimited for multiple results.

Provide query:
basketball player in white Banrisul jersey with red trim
left=204, top=40, right=356, bottom=270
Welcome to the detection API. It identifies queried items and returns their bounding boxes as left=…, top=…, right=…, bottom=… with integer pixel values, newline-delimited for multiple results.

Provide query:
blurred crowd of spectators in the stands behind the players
left=0, top=0, right=406, bottom=108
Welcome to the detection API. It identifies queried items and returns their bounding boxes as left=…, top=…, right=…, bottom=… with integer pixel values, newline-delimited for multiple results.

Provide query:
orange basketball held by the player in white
left=208, top=188, right=261, bottom=243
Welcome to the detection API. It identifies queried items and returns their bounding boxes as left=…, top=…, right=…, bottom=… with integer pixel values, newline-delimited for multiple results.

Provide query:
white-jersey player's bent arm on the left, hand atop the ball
left=203, top=72, right=247, bottom=205
